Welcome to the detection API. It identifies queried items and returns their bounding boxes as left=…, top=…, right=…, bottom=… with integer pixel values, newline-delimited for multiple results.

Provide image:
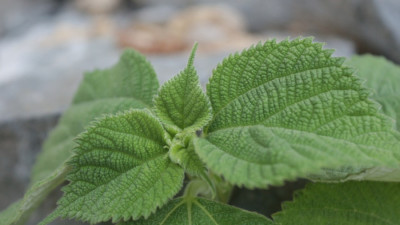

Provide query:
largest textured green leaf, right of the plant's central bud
left=195, top=38, right=400, bottom=188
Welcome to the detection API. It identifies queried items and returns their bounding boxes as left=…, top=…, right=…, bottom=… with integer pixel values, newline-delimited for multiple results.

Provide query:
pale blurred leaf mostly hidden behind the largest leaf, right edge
left=313, top=55, right=400, bottom=181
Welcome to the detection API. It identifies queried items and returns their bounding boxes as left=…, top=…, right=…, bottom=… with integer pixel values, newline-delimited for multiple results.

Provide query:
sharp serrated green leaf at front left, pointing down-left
left=41, top=110, right=184, bottom=224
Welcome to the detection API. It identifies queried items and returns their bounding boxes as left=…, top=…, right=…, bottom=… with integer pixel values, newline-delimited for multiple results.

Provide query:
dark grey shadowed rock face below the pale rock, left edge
left=0, top=115, right=58, bottom=213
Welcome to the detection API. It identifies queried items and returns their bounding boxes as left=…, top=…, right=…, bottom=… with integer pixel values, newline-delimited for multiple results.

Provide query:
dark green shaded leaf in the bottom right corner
left=273, top=181, right=400, bottom=225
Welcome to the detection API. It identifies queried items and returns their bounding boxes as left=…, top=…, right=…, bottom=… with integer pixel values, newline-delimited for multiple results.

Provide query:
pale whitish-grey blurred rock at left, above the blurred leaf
left=0, top=38, right=119, bottom=121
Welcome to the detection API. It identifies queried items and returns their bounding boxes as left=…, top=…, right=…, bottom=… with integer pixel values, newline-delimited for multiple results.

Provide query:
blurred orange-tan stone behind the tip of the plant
left=119, top=4, right=262, bottom=53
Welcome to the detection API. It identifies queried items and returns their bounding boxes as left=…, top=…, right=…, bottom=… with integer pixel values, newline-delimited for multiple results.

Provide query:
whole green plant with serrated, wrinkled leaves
left=0, top=38, right=400, bottom=225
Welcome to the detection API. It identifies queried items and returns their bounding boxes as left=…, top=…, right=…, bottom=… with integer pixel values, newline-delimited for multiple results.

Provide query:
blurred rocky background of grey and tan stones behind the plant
left=0, top=0, right=400, bottom=224
